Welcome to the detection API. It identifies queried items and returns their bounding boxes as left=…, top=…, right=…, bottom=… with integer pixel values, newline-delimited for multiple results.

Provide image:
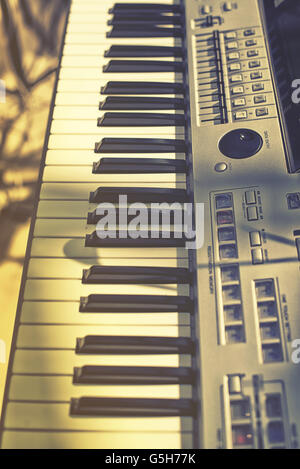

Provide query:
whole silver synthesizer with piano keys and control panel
left=0, top=0, right=300, bottom=449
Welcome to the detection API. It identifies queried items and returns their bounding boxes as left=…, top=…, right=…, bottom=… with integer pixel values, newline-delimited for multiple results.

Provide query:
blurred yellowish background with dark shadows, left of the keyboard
left=0, top=0, right=69, bottom=398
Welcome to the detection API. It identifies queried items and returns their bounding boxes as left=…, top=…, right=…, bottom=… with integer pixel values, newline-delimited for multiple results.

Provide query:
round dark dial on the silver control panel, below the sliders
left=219, top=129, right=263, bottom=160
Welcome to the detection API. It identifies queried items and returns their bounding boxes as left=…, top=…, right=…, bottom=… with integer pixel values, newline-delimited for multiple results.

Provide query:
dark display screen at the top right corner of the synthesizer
left=263, top=0, right=300, bottom=172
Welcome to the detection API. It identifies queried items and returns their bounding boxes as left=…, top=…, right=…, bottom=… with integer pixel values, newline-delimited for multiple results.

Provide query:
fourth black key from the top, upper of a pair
left=104, top=46, right=183, bottom=57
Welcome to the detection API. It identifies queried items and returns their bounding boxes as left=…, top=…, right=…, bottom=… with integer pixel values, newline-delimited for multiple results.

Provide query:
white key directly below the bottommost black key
left=5, top=402, right=192, bottom=433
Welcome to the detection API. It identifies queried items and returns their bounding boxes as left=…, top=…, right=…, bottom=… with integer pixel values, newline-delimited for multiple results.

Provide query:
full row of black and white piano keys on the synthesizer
left=2, top=0, right=197, bottom=448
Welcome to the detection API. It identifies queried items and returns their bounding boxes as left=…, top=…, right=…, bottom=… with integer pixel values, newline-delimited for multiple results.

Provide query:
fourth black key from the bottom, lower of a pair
left=79, top=295, right=193, bottom=314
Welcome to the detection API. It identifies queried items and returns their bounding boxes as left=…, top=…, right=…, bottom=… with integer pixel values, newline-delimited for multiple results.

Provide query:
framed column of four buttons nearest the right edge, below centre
left=255, top=279, right=283, bottom=363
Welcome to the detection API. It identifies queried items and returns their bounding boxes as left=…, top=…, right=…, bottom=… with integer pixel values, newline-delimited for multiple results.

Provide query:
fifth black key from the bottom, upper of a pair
left=82, top=265, right=191, bottom=285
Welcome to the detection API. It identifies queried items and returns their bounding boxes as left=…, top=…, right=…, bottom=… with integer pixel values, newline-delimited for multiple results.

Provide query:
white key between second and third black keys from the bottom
left=13, top=350, right=192, bottom=374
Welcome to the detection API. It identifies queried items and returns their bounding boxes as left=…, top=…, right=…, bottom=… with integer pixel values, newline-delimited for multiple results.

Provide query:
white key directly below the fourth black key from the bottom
left=21, top=300, right=190, bottom=326
